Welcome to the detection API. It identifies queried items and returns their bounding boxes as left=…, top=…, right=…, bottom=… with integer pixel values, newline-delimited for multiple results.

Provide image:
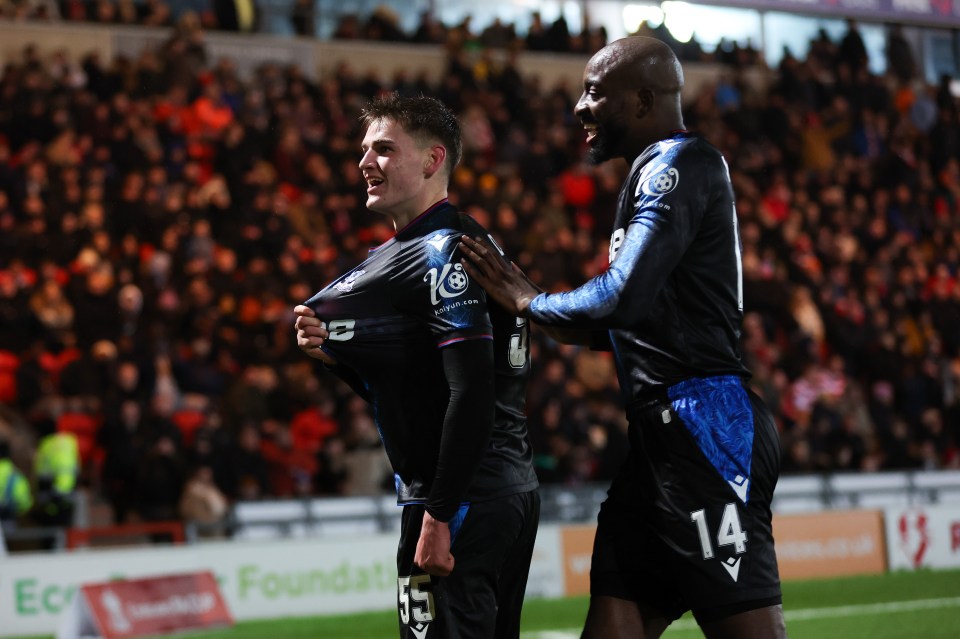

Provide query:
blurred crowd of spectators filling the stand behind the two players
left=0, top=12, right=960, bottom=536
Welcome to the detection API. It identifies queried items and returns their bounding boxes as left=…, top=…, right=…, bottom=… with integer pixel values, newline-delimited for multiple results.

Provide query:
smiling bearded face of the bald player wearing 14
left=574, top=54, right=630, bottom=164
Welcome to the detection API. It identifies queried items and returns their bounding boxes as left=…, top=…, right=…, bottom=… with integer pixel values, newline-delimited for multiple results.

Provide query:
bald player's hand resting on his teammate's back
left=460, top=235, right=541, bottom=317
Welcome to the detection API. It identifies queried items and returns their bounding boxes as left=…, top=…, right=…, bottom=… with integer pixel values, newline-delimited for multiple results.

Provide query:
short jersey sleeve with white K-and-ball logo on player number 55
left=407, top=229, right=493, bottom=347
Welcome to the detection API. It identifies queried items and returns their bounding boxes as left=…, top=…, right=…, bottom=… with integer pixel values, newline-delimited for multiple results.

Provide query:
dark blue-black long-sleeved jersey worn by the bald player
left=530, top=132, right=748, bottom=403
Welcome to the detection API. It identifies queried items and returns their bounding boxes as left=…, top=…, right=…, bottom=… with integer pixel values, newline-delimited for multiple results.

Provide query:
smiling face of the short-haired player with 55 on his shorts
left=360, top=119, right=430, bottom=222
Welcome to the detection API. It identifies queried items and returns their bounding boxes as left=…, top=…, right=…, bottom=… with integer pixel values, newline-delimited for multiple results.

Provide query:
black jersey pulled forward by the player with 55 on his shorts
left=306, top=200, right=537, bottom=520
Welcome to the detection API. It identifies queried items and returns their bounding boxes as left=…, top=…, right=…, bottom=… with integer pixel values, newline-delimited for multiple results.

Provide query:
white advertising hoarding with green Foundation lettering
left=0, top=526, right=564, bottom=637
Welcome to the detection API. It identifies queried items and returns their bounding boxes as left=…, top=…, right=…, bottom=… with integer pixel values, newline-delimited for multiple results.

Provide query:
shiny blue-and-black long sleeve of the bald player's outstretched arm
left=530, top=142, right=712, bottom=329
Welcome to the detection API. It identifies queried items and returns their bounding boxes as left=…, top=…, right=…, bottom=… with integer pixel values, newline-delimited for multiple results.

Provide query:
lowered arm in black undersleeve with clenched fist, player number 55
left=414, top=339, right=496, bottom=576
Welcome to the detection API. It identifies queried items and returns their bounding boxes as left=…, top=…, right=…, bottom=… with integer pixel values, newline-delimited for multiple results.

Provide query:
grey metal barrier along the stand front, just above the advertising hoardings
left=3, top=470, right=960, bottom=550
